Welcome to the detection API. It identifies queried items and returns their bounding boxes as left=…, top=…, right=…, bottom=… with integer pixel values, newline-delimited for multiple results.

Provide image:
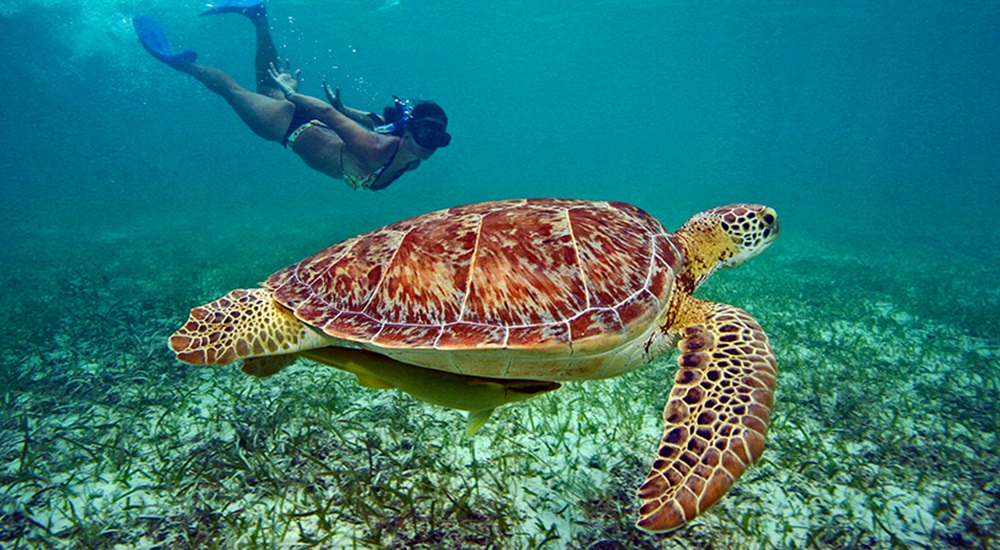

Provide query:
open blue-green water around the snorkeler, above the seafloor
left=0, top=0, right=1000, bottom=256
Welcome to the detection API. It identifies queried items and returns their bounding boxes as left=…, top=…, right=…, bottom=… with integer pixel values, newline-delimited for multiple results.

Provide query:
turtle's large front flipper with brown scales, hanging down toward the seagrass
left=636, top=299, right=777, bottom=532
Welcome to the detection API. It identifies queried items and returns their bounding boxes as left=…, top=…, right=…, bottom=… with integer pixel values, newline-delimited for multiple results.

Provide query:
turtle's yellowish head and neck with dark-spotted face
left=675, top=204, right=781, bottom=292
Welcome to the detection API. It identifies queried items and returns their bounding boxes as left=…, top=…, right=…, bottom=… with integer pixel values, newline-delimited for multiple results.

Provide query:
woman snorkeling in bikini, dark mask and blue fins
left=133, top=0, right=451, bottom=191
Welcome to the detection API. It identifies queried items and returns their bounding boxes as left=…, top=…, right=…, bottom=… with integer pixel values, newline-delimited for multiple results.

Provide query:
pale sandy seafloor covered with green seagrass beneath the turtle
left=0, top=218, right=1000, bottom=550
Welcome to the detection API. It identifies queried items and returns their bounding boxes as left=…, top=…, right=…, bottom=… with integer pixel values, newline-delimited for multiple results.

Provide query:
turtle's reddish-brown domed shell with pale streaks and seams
left=264, top=199, right=682, bottom=375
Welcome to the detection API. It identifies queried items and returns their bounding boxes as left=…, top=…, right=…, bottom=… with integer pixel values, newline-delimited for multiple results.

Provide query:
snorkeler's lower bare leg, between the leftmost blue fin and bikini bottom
left=175, top=63, right=295, bottom=142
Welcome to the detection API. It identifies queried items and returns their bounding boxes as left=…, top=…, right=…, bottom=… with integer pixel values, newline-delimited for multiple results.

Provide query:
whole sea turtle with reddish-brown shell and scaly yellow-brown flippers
left=170, top=199, right=780, bottom=532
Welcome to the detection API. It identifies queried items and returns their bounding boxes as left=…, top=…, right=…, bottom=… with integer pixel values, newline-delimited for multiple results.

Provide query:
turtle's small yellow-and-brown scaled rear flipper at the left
left=170, top=288, right=330, bottom=365
